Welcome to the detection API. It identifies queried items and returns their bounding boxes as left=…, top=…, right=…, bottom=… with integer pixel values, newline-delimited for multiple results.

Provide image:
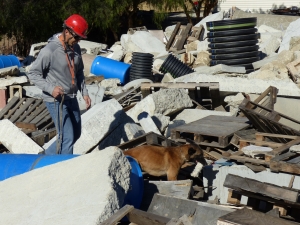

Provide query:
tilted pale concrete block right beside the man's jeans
left=73, top=99, right=126, bottom=154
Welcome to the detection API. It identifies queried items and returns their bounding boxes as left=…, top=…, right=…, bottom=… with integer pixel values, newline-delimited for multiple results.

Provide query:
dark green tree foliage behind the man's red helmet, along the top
left=0, top=0, right=217, bottom=56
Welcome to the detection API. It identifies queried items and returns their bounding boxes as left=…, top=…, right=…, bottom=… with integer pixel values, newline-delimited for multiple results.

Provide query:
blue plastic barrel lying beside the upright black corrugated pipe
left=91, top=56, right=131, bottom=85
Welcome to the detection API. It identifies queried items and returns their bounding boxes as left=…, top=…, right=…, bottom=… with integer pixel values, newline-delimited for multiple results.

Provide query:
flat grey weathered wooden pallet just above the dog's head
left=171, top=116, right=249, bottom=148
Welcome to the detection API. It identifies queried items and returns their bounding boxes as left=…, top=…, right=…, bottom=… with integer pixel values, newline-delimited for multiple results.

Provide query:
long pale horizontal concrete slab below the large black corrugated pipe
left=175, top=72, right=300, bottom=97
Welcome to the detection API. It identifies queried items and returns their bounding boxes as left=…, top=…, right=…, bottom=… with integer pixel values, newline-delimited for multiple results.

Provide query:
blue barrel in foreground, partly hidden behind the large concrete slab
left=0, top=154, right=144, bottom=209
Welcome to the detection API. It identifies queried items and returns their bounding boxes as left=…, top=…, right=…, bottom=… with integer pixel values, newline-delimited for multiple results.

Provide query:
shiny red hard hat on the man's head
left=64, top=14, right=88, bottom=38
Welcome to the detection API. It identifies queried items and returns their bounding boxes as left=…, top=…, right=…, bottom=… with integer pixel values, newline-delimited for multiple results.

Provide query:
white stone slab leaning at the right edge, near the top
left=278, top=19, right=300, bottom=53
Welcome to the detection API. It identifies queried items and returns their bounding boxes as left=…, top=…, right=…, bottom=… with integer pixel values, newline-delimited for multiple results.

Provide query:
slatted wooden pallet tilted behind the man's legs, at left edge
left=0, top=97, right=56, bottom=145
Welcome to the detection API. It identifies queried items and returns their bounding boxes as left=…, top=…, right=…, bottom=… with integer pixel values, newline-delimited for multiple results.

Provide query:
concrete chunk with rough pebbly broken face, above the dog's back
left=126, top=89, right=193, bottom=122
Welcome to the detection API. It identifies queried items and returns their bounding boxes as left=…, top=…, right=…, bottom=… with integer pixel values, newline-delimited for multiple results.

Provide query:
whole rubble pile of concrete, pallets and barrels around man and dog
left=0, top=9, right=300, bottom=225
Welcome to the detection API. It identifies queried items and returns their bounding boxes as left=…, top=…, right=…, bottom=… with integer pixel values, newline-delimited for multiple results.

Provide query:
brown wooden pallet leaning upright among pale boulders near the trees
left=166, top=22, right=192, bottom=52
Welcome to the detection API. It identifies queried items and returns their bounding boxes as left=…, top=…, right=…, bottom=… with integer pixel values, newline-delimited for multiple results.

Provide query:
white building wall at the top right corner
left=218, top=0, right=300, bottom=13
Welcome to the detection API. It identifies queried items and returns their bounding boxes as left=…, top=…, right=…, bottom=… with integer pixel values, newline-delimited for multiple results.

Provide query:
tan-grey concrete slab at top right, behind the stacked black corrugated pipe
left=232, top=8, right=300, bottom=31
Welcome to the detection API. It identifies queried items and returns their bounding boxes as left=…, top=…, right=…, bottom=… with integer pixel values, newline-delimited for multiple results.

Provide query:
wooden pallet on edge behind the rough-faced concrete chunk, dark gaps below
left=141, top=82, right=221, bottom=109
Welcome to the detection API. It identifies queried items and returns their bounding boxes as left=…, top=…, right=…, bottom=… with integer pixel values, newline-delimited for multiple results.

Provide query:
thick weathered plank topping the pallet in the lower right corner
left=224, top=174, right=299, bottom=203
